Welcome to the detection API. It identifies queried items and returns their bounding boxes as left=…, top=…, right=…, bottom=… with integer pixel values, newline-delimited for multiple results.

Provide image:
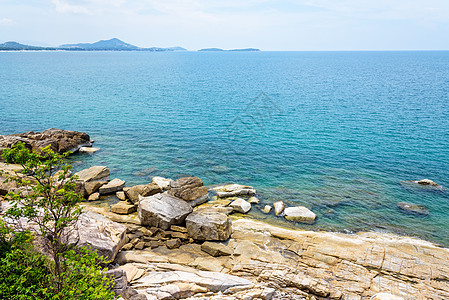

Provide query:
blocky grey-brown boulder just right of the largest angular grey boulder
left=186, top=211, right=232, bottom=241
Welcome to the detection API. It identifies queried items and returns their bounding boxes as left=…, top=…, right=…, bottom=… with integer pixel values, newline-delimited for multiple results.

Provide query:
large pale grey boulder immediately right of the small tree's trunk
left=69, top=211, right=126, bottom=260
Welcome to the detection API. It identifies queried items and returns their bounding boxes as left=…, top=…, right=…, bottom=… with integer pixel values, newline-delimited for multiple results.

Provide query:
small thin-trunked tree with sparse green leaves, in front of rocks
left=2, top=143, right=111, bottom=299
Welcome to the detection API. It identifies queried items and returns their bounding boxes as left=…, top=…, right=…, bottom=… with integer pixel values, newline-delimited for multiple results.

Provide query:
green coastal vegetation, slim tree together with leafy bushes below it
left=0, top=142, right=113, bottom=299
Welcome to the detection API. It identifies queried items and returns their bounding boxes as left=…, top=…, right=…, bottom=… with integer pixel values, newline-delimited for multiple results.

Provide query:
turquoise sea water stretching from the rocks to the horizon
left=0, top=52, right=449, bottom=246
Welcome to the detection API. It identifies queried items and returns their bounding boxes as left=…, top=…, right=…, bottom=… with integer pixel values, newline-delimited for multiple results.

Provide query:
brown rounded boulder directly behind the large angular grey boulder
left=168, top=177, right=208, bottom=206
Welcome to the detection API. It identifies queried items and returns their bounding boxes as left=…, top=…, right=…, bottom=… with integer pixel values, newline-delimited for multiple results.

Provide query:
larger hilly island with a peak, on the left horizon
left=0, top=38, right=187, bottom=51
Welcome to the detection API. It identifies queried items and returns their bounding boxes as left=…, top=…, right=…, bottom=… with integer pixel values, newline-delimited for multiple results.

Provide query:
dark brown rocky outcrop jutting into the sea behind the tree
left=0, top=128, right=92, bottom=158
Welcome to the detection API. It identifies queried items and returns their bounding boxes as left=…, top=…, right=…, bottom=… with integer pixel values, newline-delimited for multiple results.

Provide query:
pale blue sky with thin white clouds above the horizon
left=0, top=0, right=449, bottom=51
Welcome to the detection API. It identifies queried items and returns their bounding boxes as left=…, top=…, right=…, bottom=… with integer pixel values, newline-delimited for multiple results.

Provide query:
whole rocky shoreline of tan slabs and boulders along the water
left=0, top=129, right=449, bottom=300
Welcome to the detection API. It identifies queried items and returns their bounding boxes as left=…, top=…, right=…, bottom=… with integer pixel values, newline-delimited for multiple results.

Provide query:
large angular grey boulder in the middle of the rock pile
left=138, top=193, right=192, bottom=230
